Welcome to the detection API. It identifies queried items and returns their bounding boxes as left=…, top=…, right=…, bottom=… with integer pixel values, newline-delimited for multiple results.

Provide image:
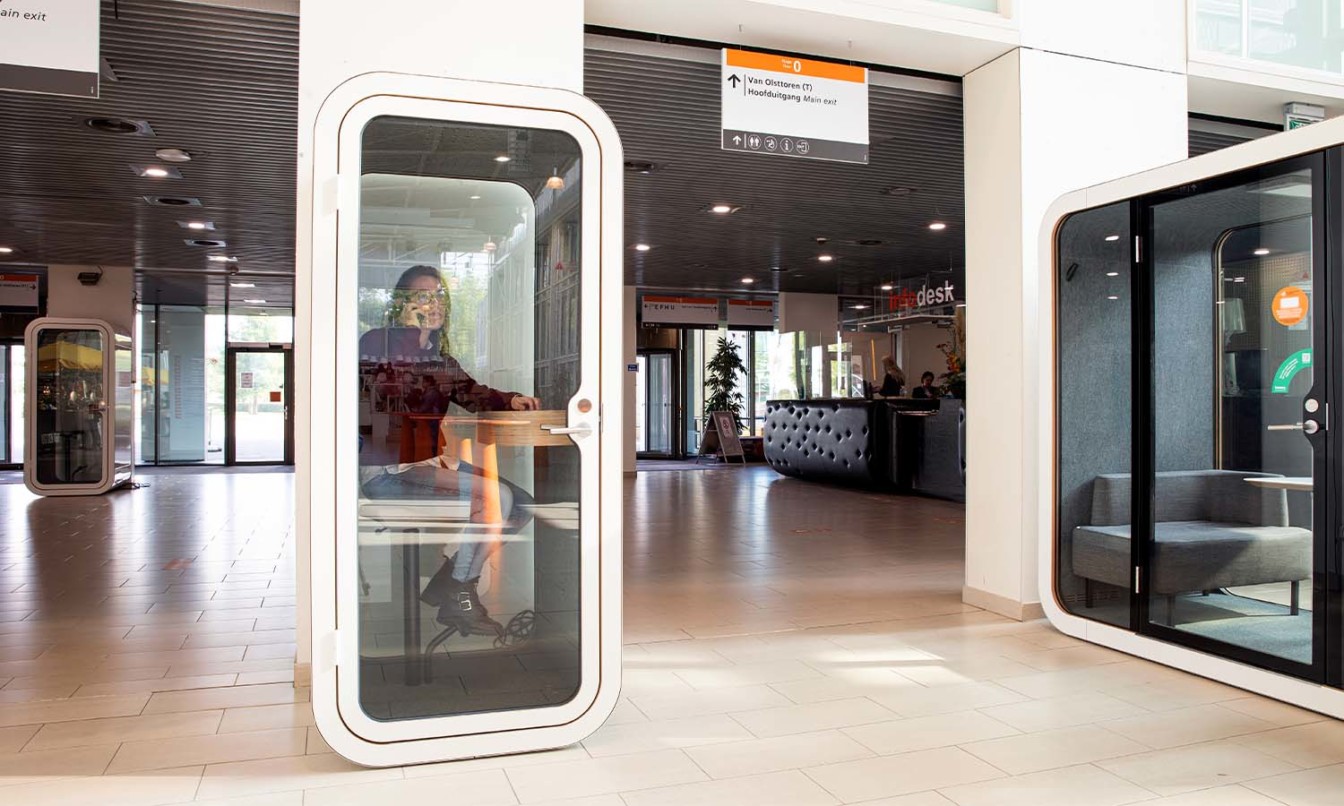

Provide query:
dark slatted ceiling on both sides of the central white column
left=0, top=0, right=964, bottom=304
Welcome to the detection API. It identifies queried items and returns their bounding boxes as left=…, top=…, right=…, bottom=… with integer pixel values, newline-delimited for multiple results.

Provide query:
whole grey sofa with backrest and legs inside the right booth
left=1073, top=470, right=1312, bottom=623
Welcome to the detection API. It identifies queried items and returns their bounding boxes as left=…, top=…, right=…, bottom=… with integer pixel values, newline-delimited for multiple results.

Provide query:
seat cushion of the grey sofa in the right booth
left=1074, top=520, right=1312, bottom=594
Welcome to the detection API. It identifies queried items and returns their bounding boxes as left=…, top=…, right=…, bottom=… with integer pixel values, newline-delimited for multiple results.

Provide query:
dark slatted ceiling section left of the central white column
left=0, top=0, right=298, bottom=304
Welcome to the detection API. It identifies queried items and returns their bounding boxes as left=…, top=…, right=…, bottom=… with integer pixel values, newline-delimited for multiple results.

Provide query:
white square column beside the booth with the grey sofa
left=962, top=43, right=1187, bottom=618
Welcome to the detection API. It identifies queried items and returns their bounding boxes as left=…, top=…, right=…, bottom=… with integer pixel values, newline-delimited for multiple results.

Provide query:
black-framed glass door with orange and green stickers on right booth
left=1134, top=156, right=1331, bottom=678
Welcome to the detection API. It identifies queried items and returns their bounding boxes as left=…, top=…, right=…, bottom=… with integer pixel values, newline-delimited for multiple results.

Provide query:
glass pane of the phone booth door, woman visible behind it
left=354, top=117, right=591, bottom=720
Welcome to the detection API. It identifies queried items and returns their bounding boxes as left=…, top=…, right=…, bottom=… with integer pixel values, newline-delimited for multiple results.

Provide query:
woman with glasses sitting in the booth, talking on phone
left=359, top=266, right=540, bottom=635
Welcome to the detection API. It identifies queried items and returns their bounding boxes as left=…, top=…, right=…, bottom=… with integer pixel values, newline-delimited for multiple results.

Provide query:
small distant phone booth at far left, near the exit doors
left=23, top=318, right=136, bottom=496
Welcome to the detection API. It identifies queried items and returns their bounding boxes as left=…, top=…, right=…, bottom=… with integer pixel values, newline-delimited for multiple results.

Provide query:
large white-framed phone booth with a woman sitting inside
left=309, top=74, right=624, bottom=766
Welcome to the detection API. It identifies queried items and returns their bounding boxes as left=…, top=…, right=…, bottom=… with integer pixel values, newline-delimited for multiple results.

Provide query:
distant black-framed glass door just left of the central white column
left=224, top=348, right=294, bottom=465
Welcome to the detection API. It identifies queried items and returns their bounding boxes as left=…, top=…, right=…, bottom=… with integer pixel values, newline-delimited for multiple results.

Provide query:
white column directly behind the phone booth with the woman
left=294, top=0, right=583, bottom=685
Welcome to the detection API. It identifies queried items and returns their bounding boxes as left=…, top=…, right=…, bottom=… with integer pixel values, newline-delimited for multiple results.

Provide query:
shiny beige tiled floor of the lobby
left=0, top=467, right=1344, bottom=806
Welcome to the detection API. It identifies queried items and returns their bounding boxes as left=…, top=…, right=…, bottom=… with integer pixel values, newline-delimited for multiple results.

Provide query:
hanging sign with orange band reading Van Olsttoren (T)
left=719, top=48, right=868, bottom=165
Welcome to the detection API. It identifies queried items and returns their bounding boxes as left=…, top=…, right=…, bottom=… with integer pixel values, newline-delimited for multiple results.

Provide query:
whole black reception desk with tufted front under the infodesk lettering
left=765, top=398, right=966, bottom=501
